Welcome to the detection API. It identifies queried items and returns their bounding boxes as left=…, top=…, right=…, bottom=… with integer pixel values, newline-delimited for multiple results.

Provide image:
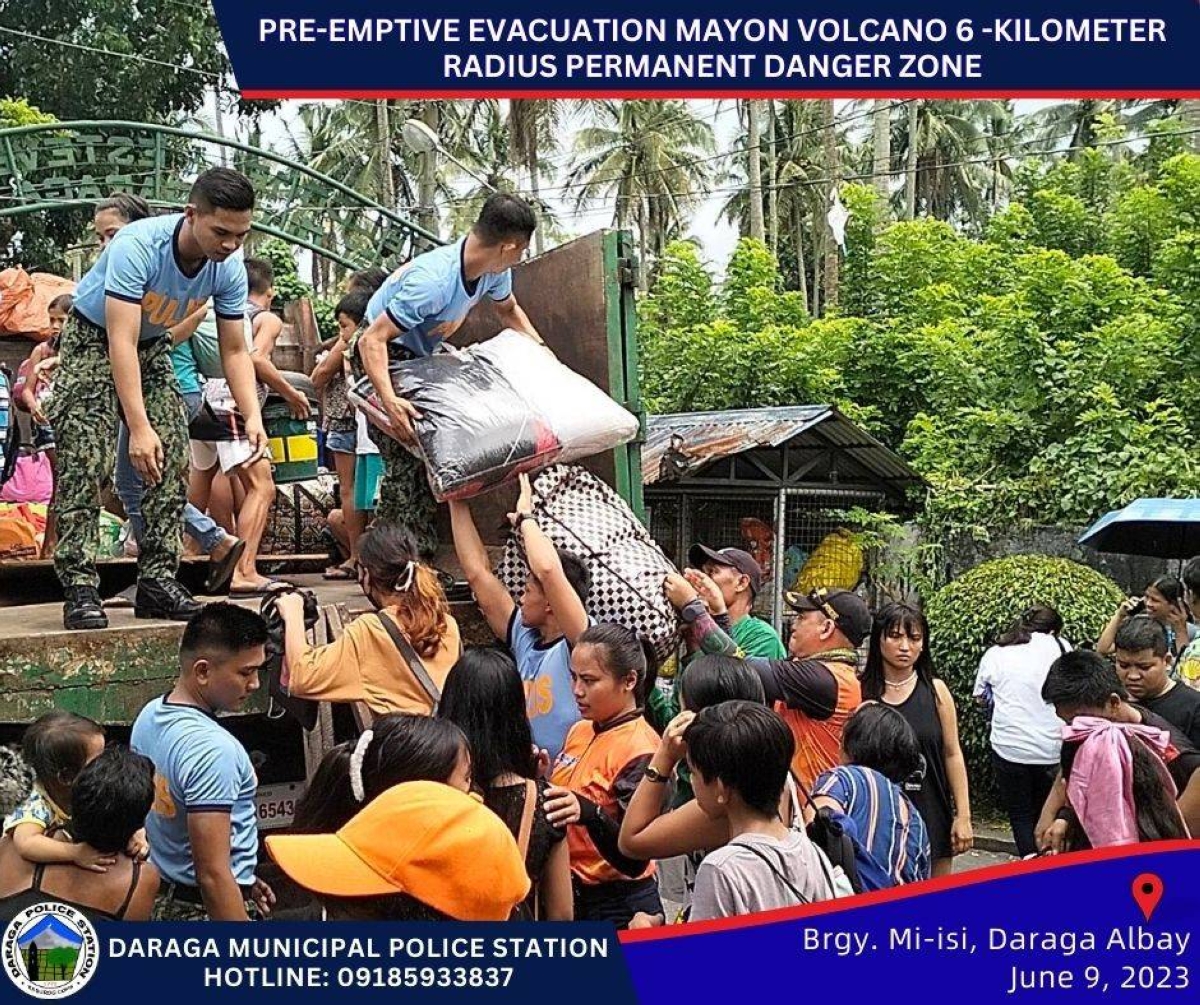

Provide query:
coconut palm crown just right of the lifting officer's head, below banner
left=564, top=101, right=715, bottom=282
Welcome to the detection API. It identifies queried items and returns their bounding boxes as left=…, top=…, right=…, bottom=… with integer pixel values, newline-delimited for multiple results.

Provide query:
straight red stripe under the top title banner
left=241, top=88, right=1200, bottom=101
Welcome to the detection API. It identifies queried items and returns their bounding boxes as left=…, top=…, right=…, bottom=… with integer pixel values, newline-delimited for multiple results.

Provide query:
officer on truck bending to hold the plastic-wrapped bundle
left=354, top=192, right=541, bottom=559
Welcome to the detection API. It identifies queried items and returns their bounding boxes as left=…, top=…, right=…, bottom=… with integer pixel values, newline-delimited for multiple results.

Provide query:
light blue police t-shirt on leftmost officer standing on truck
left=74, top=213, right=247, bottom=342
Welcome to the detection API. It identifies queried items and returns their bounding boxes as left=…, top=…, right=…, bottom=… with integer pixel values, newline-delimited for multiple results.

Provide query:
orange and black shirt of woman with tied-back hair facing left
left=551, top=714, right=659, bottom=886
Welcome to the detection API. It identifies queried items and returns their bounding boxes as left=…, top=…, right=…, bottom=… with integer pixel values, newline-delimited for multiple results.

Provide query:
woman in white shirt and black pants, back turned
left=974, top=604, right=1070, bottom=857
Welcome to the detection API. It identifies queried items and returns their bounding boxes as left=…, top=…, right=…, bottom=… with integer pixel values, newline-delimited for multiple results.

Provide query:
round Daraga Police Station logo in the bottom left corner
left=0, top=902, right=100, bottom=999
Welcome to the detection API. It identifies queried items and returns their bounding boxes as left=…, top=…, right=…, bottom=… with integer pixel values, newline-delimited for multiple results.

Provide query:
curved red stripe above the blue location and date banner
left=617, top=838, right=1200, bottom=943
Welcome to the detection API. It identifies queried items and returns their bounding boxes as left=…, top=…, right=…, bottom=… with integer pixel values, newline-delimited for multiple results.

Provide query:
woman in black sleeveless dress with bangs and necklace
left=862, top=603, right=972, bottom=877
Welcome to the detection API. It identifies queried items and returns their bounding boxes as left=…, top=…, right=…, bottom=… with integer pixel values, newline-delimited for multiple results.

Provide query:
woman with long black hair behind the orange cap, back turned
left=438, top=646, right=574, bottom=921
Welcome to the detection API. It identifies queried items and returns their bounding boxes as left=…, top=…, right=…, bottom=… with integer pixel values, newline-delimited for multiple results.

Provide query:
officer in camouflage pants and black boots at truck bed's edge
left=49, top=168, right=266, bottom=628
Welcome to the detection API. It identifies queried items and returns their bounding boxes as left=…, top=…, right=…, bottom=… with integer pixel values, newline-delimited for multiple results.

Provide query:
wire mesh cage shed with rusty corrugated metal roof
left=642, top=405, right=923, bottom=628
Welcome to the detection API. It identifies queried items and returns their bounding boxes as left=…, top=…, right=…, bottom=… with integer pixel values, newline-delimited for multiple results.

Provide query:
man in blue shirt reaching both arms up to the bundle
left=450, top=475, right=590, bottom=764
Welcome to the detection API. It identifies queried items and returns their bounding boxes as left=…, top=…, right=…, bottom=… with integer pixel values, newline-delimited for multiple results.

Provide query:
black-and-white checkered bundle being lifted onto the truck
left=497, top=464, right=678, bottom=660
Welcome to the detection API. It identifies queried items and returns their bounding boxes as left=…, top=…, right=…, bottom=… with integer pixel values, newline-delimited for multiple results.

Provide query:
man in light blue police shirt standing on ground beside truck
left=130, top=603, right=274, bottom=921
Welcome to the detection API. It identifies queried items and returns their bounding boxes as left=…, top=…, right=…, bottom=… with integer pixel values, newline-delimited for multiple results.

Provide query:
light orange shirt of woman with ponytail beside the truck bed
left=288, top=608, right=462, bottom=715
